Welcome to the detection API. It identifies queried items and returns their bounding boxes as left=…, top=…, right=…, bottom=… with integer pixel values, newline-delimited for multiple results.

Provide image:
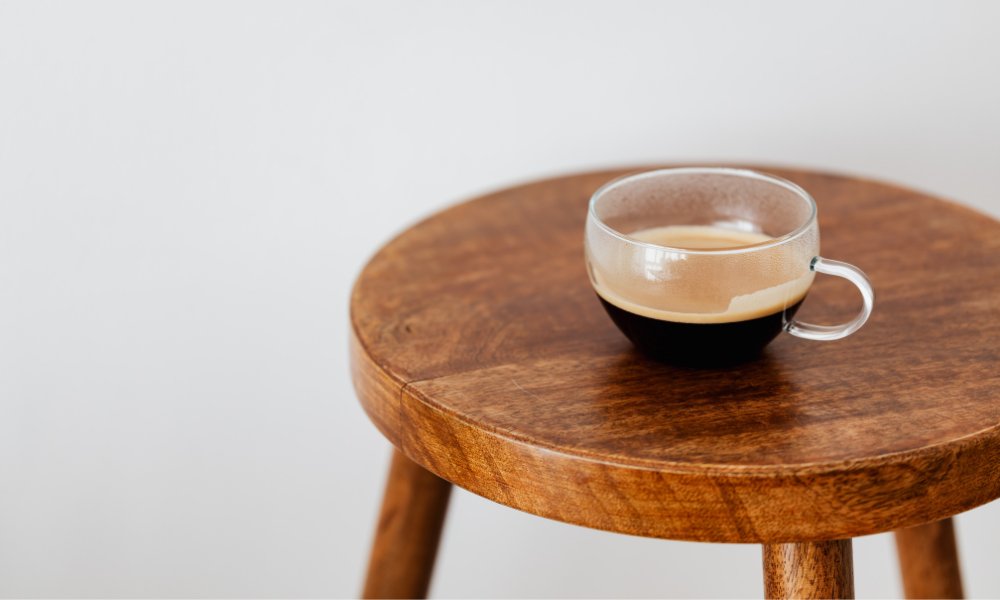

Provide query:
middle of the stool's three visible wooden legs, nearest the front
left=764, top=540, right=854, bottom=598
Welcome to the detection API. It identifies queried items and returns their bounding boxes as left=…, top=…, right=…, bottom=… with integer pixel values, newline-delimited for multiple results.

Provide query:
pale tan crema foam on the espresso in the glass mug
left=592, top=226, right=815, bottom=323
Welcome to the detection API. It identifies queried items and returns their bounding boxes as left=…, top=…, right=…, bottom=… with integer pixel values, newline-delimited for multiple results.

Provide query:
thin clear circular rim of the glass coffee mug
left=587, top=167, right=816, bottom=256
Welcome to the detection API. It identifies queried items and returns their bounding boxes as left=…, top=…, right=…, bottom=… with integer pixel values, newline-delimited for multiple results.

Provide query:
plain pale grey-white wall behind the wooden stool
left=0, top=1, right=1000, bottom=597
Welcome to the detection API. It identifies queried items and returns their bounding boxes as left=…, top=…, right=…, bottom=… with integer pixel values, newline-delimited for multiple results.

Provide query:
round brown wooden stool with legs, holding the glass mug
left=351, top=168, right=1000, bottom=598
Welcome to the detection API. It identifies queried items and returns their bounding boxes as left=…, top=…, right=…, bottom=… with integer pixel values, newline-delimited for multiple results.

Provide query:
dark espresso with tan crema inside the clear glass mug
left=595, top=226, right=811, bottom=366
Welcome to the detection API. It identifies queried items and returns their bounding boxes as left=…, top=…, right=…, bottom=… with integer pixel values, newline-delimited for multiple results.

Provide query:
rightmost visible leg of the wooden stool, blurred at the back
left=896, top=519, right=962, bottom=598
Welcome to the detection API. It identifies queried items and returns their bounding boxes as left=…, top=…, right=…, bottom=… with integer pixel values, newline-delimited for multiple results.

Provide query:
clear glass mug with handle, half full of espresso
left=584, top=167, right=875, bottom=365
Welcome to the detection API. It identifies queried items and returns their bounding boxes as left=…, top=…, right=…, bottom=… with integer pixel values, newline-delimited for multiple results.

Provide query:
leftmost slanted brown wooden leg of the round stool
left=362, top=450, right=451, bottom=598
